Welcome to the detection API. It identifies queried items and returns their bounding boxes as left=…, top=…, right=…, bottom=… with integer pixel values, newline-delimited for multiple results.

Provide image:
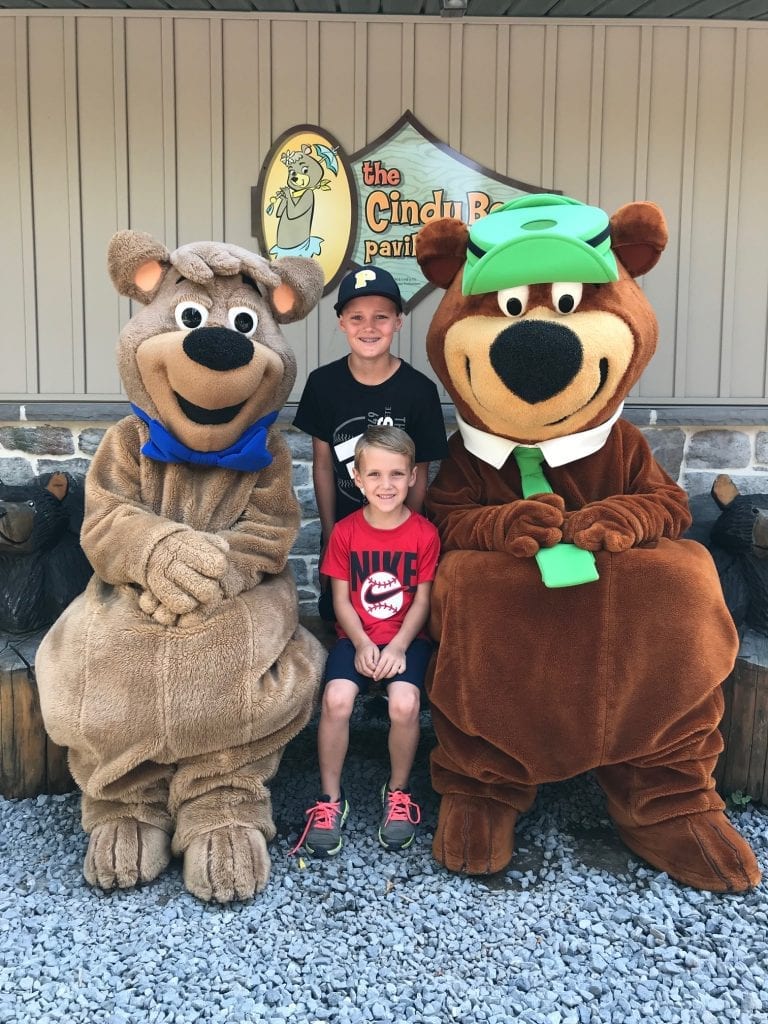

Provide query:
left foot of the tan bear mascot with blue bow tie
left=83, top=818, right=171, bottom=889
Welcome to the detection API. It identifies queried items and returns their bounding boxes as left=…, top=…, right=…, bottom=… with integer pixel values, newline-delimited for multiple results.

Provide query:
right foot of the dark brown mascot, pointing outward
left=618, top=811, right=761, bottom=893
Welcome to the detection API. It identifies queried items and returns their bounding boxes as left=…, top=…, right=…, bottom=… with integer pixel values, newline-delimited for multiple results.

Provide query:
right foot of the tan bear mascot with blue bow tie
left=184, top=825, right=272, bottom=903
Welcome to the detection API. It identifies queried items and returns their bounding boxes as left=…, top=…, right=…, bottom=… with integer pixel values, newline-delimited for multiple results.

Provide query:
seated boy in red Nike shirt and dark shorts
left=295, top=426, right=439, bottom=856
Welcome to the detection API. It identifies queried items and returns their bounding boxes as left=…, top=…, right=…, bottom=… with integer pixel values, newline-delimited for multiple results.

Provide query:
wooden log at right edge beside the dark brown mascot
left=715, top=629, right=768, bottom=804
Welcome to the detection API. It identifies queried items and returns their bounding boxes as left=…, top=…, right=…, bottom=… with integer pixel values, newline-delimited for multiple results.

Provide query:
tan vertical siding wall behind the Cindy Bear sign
left=0, top=11, right=768, bottom=403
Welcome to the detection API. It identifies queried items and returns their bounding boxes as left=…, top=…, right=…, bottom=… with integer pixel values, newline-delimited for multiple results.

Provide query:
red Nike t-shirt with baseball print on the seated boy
left=321, top=509, right=440, bottom=645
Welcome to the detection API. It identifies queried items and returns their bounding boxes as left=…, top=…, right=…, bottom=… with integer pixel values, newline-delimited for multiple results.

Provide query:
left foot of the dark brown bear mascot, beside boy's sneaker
left=432, top=793, right=518, bottom=874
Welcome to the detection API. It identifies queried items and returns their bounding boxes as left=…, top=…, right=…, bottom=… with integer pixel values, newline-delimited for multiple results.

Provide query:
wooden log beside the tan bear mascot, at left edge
left=0, top=630, right=75, bottom=799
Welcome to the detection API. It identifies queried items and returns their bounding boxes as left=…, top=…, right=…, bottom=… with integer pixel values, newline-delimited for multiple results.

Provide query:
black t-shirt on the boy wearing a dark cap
left=293, top=355, right=447, bottom=522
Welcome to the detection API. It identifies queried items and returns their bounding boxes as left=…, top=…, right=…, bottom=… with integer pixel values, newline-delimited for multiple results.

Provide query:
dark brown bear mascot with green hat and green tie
left=417, top=196, right=760, bottom=892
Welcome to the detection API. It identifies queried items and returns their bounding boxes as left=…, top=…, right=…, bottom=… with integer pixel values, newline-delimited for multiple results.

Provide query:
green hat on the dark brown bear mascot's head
left=462, top=195, right=618, bottom=295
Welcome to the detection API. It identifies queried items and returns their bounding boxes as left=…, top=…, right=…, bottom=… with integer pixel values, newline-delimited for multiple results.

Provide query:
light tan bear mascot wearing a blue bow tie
left=36, top=231, right=324, bottom=902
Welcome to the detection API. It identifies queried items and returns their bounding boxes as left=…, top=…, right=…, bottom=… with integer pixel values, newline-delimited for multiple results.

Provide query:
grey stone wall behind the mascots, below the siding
left=0, top=409, right=768, bottom=614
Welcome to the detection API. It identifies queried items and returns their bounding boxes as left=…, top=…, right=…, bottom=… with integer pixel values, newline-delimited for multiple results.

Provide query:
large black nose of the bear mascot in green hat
left=490, top=321, right=583, bottom=404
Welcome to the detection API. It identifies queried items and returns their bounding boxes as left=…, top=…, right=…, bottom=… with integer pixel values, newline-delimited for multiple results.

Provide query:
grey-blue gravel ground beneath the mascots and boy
left=0, top=701, right=768, bottom=1024
